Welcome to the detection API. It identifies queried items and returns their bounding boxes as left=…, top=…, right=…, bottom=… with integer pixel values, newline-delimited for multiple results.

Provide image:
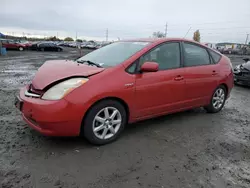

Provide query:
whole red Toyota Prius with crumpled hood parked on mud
left=15, top=38, right=234, bottom=145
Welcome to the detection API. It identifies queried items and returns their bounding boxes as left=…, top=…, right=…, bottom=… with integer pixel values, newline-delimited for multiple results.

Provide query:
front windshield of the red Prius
left=77, top=42, right=149, bottom=67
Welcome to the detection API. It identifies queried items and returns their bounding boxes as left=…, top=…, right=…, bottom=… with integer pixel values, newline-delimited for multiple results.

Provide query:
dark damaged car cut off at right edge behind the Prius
left=234, top=58, right=250, bottom=86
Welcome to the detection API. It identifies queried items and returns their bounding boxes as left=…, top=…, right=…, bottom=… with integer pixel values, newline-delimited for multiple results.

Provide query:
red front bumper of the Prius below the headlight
left=20, top=88, right=84, bottom=136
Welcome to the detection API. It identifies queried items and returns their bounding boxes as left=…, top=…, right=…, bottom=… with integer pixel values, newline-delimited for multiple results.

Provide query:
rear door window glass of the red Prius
left=183, top=43, right=210, bottom=67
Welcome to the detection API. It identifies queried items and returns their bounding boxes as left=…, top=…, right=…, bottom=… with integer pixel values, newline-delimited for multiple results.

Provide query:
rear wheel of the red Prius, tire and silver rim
left=204, top=85, right=227, bottom=113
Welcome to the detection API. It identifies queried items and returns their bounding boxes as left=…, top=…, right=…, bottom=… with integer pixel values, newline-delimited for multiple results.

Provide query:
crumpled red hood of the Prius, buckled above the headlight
left=32, top=60, right=104, bottom=90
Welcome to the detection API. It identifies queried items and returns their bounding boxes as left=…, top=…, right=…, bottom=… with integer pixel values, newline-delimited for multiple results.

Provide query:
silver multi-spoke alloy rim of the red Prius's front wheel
left=92, top=107, right=122, bottom=140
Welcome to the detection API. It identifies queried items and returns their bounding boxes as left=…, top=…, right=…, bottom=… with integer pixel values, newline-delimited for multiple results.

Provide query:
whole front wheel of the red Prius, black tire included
left=81, top=100, right=127, bottom=145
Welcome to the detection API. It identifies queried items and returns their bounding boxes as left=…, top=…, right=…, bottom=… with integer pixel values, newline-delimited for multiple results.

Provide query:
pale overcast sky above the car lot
left=0, top=0, right=250, bottom=43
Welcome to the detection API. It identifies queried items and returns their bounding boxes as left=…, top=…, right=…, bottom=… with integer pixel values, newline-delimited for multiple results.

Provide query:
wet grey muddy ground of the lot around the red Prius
left=0, top=49, right=250, bottom=188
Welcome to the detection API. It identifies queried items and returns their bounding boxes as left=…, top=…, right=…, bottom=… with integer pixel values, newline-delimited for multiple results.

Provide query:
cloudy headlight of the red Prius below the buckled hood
left=42, top=78, right=88, bottom=100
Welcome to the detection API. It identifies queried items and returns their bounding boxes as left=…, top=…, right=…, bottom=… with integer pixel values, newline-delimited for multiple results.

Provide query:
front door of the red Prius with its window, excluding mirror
left=135, top=42, right=185, bottom=119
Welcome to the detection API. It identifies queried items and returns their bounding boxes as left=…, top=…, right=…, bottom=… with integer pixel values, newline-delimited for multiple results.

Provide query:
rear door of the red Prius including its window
left=182, top=42, right=219, bottom=106
